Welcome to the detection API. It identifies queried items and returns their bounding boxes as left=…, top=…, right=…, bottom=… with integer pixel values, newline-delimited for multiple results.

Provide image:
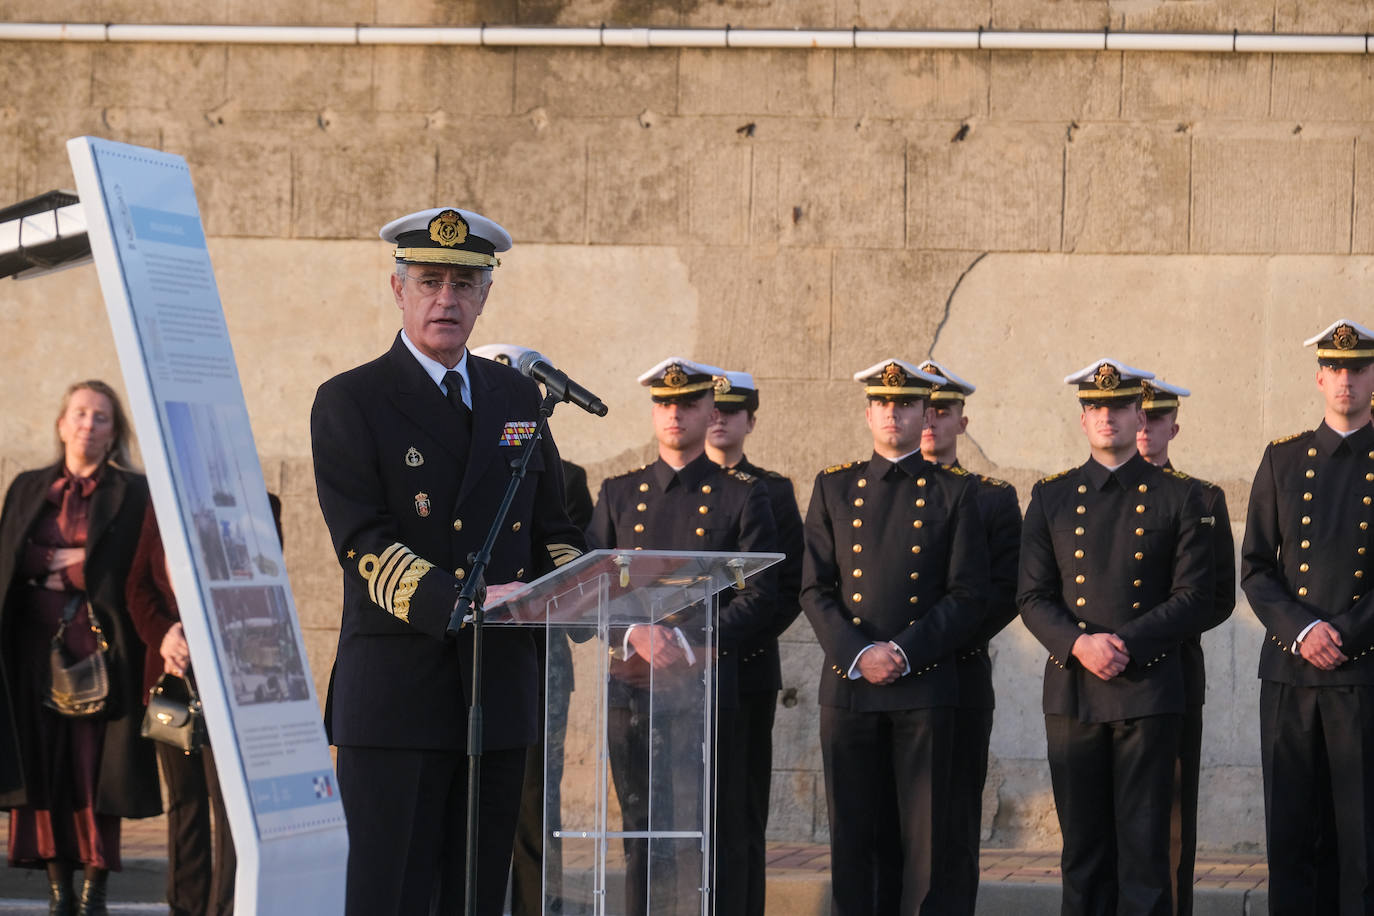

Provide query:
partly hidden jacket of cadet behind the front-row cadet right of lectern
left=955, top=461, right=1021, bottom=709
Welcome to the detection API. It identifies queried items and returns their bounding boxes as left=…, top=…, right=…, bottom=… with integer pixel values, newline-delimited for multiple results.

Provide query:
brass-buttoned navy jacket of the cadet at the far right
left=1241, top=423, right=1374, bottom=687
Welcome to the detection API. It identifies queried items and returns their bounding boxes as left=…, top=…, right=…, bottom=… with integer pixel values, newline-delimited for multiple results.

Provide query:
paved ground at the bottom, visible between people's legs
left=0, top=814, right=1268, bottom=916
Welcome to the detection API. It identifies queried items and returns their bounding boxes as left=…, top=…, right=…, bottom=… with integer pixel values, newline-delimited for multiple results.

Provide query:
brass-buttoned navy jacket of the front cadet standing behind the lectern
left=587, top=453, right=778, bottom=707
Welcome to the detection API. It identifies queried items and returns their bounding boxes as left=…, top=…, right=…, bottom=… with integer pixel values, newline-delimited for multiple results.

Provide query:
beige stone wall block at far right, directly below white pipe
left=1271, top=54, right=1374, bottom=122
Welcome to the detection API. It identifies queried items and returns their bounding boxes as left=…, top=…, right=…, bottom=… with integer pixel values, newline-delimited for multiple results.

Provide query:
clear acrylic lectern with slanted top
left=486, top=551, right=783, bottom=916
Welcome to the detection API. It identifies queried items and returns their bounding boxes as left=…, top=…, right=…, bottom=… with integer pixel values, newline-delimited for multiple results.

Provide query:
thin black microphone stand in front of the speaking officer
left=448, top=386, right=566, bottom=916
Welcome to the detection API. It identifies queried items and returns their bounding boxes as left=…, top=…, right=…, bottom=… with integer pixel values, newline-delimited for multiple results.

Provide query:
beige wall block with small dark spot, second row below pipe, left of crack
left=750, top=139, right=905, bottom=249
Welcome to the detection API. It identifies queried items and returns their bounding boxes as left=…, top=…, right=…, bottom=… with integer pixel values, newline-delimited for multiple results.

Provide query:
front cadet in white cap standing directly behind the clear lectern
left=588, top=357, right=776, bottom=916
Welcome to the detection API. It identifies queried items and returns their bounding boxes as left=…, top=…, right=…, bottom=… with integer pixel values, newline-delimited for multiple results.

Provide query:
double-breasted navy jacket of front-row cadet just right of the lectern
left=801, top=452, right=988, bottom=711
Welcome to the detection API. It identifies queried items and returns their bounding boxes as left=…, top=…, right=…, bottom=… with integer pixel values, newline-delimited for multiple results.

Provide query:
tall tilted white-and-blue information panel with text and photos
left=67, top=137, right=348, bottom=916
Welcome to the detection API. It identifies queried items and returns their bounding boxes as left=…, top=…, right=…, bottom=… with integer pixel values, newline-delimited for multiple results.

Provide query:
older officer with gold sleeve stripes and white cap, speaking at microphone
left=311, top=207, right=583, bottom=916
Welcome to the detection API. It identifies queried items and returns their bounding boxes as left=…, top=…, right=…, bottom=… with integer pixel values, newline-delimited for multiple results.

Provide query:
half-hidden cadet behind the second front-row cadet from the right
left=1135, top=378, right=1235, bottom=916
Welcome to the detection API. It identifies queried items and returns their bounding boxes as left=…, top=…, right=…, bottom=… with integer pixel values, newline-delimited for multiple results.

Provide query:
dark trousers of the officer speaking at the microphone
left=338, top=747, right=526, bottom=916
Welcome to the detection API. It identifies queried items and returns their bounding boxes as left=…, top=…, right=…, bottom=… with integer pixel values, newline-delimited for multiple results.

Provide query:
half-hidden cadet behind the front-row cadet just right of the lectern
left=921, top=360, right=1021, bottom=916
